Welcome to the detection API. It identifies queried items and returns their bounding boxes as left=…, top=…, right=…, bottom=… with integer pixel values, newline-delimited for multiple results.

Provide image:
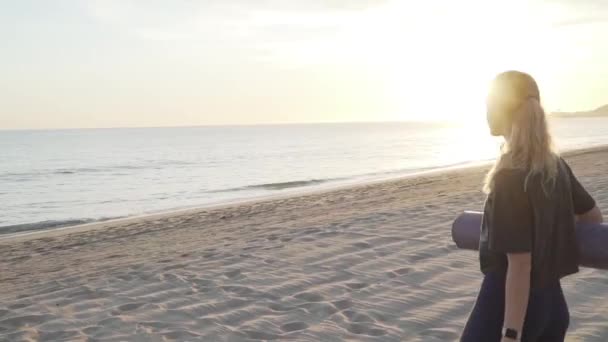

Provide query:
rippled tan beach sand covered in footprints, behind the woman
left=0, top=148, right=608, bottom=341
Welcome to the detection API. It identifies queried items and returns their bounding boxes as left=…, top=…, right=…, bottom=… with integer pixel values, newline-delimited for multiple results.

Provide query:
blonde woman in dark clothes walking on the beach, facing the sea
left=461, top=71, right=602, bottom=342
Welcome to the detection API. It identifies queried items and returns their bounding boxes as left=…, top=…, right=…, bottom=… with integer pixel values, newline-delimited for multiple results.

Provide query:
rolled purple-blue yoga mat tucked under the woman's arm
left=452, top=211, right=608, bottom=270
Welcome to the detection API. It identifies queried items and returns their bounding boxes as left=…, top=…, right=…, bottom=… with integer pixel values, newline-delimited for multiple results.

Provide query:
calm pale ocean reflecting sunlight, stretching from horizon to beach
left=0, top=118, right=608, bottom=234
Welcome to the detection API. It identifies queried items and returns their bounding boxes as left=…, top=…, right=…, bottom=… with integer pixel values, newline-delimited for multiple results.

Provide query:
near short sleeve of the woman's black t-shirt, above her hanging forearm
left=488, top=170, right=534, bottom=253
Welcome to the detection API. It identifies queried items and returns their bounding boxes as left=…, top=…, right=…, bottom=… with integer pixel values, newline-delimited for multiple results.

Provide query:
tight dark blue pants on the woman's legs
left=460, top=273, right=570, bottom=342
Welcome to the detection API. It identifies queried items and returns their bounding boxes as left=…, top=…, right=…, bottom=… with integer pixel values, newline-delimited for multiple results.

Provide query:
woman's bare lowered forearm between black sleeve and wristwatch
left=503, top=253, right=532, bottom=341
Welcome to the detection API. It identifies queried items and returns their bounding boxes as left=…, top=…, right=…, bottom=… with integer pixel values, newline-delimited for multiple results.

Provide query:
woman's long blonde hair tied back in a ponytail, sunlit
left=483, top=71, right=559, bottom=194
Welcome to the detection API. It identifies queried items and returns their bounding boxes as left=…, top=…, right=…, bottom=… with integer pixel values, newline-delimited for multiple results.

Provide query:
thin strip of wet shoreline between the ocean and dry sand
left=0, top=144, right=608, bottom=242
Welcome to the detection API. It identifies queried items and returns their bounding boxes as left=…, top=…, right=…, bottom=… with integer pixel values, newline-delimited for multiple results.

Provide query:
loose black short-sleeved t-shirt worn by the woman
left=479, top=158, right=595, bottom=288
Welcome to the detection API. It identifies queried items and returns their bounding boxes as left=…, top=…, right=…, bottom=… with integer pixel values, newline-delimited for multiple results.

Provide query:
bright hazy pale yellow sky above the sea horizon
left=0, top=0, right=608, bottom=129
